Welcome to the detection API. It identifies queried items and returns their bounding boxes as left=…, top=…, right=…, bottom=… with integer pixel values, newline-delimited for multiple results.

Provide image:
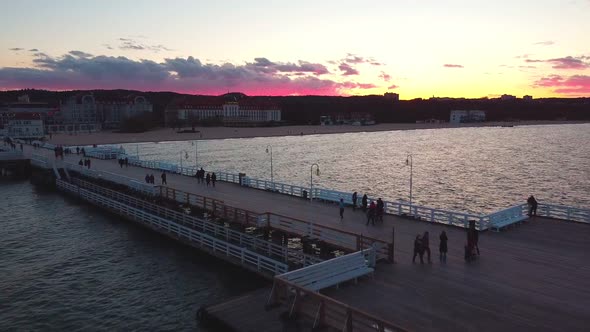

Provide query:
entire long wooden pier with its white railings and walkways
left=19, top=141, right=590, bottom=331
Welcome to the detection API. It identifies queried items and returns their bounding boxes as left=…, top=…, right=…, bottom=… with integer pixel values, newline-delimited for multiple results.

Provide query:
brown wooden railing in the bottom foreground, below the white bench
left=271, top=277, right=407, bottom=332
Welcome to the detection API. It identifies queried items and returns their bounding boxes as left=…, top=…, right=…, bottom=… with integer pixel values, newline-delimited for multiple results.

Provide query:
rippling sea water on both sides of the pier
left=0, top=124, right=590, bottom=331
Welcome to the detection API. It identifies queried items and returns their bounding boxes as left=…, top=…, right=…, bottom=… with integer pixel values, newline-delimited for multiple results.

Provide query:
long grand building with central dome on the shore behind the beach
left=171, top=93, right=281, bottom=127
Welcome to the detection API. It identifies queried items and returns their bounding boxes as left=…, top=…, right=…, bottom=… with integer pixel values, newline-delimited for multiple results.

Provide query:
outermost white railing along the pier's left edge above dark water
left=56, top=180, right=288, bottom=275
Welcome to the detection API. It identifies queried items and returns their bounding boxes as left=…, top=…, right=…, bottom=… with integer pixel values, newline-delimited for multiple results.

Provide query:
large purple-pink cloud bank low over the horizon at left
left=0, top=51, right=377, bottom=95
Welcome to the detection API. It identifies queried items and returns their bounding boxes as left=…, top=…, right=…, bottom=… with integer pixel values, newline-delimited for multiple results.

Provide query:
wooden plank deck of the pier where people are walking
left=25, top=147, right=590, bottom=332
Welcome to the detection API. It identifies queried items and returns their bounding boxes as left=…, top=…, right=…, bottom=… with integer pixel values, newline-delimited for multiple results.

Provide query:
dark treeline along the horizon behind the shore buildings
left=0, top=90, right=590, bottom=125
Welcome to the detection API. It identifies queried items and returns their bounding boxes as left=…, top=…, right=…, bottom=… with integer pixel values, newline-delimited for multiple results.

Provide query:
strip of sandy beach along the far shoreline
left=49, top=121, right=586, bottom=145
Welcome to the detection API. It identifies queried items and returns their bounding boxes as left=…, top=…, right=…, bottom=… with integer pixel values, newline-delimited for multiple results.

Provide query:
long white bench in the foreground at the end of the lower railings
left=278, top=251, right=374, bottom=292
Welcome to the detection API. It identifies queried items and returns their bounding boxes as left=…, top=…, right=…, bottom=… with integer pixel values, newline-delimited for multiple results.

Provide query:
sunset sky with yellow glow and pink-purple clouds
left=0, top=0, right=590, bottom=99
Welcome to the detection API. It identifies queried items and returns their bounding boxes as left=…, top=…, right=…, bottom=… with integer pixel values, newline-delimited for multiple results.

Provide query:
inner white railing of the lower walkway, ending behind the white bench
left=72, top=178, right=323, bottom=266
